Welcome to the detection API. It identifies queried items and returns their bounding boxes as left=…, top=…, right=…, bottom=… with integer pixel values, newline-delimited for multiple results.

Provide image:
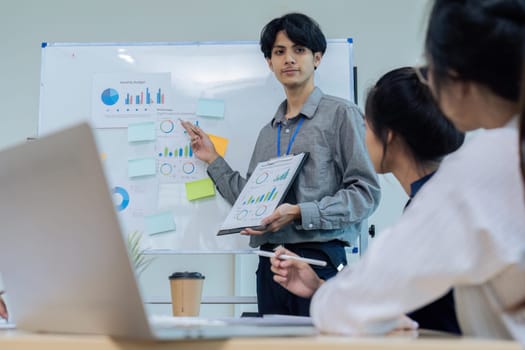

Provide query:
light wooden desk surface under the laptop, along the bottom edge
left=0, top=330, right=521, bottom=350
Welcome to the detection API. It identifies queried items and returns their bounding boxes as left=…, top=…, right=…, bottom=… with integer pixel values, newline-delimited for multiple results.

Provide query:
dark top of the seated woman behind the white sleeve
left=405, top=173, right=461, bottom=334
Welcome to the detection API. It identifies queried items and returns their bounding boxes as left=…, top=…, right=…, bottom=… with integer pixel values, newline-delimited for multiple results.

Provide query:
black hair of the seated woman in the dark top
left=365, top=67, right=465, bottom=170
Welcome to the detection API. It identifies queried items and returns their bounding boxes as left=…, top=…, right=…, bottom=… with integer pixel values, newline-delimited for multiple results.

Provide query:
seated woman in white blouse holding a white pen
left=272, top=0, right=525, bottom=345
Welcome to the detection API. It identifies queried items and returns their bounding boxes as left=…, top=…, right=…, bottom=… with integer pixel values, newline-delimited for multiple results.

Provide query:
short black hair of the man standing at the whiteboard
left=260, top=13, right=326, bottom=58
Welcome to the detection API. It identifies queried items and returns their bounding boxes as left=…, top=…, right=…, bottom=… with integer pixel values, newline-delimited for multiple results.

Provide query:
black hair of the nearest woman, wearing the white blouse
left=425, top=0, right=525, bottom=102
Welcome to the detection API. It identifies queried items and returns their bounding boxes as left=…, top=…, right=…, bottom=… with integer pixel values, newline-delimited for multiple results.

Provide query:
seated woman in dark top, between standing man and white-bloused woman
left=275, top=67, right=464, bottom=334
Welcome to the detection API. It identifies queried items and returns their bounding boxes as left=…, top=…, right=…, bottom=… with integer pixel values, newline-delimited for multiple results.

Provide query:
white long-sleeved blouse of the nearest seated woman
left=311, top=121, right=525, bottom=338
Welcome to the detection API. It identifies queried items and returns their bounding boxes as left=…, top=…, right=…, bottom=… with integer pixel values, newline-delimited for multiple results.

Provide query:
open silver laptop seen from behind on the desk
left=0, top=123, right=317, bottom=340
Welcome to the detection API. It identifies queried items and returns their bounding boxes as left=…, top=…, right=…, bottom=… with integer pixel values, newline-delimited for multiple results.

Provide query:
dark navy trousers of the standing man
left=256, top=240, right=347, bottom=316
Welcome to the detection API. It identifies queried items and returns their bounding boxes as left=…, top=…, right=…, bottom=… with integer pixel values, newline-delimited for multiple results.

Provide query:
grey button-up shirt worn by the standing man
left=208, top=88, right=380, bottom=247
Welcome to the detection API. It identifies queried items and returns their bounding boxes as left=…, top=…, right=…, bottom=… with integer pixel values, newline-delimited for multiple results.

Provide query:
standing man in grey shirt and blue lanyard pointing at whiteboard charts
left=182, top=13, right=380, bottom=316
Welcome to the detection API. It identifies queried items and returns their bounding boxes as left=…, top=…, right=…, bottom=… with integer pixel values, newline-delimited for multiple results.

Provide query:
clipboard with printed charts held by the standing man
left=217, top=153, right=308, bottom=236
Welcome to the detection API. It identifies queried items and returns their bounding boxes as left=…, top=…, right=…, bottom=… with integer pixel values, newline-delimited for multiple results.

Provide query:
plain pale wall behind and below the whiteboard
left=0, top=0, right=429, bottom=315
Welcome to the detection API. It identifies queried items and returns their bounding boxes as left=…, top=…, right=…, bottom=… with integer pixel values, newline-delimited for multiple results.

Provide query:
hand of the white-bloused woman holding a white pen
left=270, top=248, right=324, bottom=298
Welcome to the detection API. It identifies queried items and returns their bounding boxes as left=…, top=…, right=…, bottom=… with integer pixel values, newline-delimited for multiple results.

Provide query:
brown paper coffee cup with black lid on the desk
left=169, top=271, right=204, bottom=316
